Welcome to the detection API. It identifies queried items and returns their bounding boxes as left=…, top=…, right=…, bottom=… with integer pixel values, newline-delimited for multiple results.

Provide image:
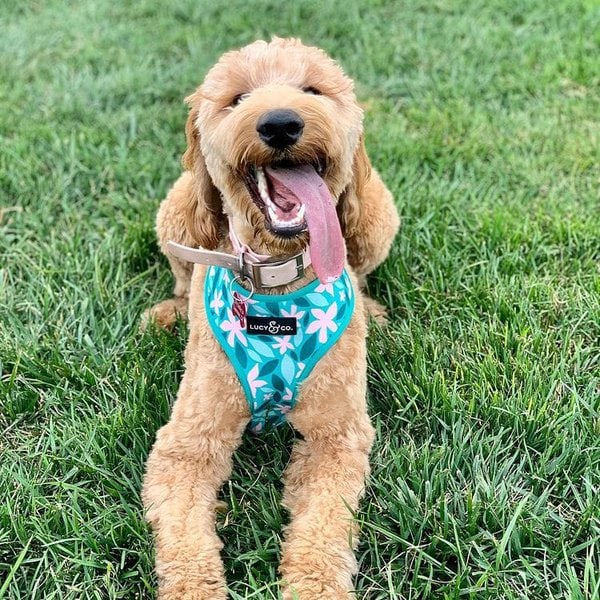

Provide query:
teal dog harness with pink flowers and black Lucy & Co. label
left=204, top=266, right=354, bottom=433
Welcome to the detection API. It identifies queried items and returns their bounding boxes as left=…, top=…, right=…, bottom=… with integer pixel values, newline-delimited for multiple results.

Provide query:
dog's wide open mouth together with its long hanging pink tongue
left=244, top=161, right=346, bottom=281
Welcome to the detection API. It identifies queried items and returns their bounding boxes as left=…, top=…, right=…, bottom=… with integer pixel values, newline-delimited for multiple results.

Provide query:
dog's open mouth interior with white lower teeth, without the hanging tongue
left=244, top=161, right=324, bottom=237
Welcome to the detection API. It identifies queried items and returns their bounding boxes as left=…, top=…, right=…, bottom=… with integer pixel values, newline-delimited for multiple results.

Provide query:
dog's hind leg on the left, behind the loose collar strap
left=142, top=172, right=196, bottom=329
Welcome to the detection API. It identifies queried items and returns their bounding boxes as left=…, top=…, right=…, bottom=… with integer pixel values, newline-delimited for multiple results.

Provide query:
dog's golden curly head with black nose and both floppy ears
left=183, top=38, right=370, bottom=278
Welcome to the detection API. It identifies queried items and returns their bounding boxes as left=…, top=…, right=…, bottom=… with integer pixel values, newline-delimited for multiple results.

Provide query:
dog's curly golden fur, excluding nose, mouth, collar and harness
left=143, top=38, right=399, bottom=600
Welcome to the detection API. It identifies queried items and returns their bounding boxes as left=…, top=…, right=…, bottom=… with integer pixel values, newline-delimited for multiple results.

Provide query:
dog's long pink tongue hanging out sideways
left=265, top=165, right=346, bottom=283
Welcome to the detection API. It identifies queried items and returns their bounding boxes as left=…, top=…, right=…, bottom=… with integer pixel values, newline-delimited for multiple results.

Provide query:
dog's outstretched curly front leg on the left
left=143, top=373, right=248, bottom=600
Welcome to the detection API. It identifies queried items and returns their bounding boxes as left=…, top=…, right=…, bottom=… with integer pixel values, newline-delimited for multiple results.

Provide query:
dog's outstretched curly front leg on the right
left=280, top=386, right=373, bottom=600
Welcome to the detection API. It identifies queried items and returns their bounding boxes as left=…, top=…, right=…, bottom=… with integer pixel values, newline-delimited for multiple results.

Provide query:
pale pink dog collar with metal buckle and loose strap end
left=167, top=220, right=311, bottom=288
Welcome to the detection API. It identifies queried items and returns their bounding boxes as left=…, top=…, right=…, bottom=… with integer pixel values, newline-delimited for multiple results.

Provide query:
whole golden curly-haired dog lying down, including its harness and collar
left=143, top=38, right=399, bottom=600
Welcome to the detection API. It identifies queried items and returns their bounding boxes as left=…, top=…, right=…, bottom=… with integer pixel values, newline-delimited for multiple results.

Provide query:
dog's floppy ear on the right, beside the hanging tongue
left=337, top=135, right=371, bottom=240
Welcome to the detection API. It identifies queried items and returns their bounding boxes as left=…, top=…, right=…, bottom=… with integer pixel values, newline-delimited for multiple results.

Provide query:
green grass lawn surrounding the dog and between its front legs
left=0, top=0, right=600, bottom=600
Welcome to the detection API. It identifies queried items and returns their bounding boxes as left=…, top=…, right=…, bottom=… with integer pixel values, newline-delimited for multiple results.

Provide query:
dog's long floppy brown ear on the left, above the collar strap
left=182, top=91, right=224, bottom=250
